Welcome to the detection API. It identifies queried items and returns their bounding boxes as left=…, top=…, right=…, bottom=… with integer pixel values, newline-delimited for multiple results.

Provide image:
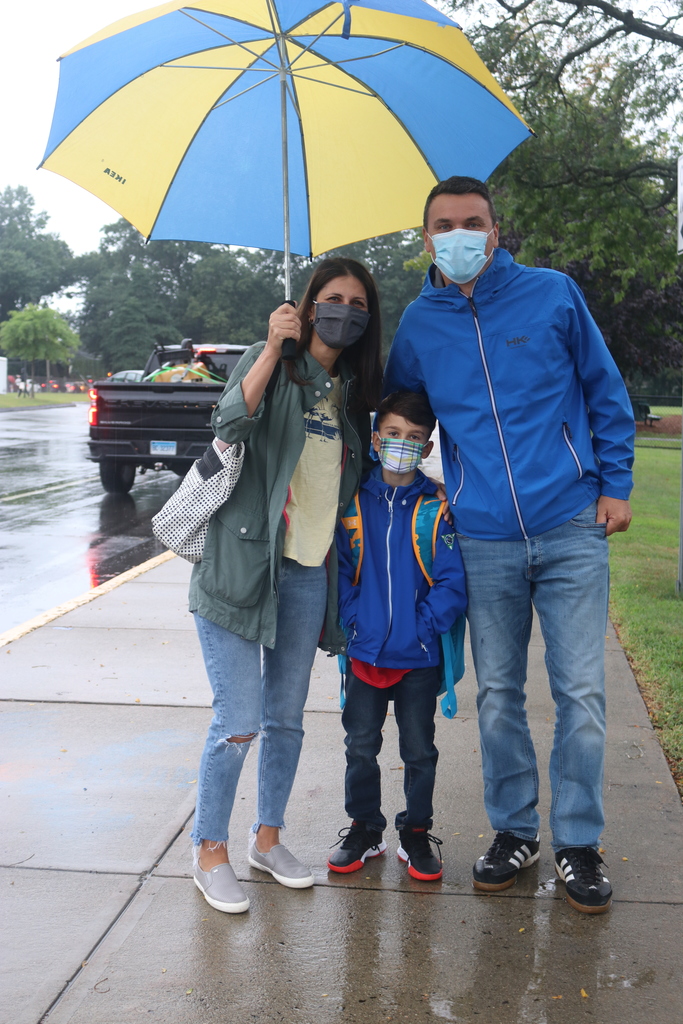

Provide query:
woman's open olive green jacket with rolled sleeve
left=189, top=342, right=371, bottom=654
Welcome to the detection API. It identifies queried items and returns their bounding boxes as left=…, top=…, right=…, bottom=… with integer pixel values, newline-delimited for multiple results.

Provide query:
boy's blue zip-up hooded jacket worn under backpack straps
left=337, top=466, right=467, bottom=669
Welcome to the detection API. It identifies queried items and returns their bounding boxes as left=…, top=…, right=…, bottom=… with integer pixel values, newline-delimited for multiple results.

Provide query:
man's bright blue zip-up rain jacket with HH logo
left=384, top=249, right=635, bottom=541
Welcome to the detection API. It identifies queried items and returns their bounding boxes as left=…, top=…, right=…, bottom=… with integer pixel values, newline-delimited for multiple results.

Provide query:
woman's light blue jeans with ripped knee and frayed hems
left=193, top=558, right=328, bottom=846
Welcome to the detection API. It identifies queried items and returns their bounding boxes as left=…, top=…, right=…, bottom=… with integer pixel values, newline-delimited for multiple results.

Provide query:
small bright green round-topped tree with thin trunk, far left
left=0, top=303, right=79, bottom=395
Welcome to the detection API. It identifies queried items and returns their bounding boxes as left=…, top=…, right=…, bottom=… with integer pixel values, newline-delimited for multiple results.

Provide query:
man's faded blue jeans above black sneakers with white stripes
left=458, top=503, right=609, bottom=850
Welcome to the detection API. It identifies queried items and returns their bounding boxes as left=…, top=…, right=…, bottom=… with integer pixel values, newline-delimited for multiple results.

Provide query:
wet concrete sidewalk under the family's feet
left=0, top=558, right=683, bottom=1024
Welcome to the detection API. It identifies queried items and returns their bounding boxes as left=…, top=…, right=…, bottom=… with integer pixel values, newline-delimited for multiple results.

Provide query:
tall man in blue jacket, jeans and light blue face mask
left=385, top=177, right=634, bottom=913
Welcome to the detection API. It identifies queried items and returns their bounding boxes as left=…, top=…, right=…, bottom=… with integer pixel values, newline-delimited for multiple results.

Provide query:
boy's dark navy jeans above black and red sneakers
left=342, top=668, right=439, bottom=831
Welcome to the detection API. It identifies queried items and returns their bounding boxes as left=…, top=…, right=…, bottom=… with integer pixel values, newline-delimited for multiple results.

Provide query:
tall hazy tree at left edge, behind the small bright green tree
left=0, top=185, right=75, bottom=321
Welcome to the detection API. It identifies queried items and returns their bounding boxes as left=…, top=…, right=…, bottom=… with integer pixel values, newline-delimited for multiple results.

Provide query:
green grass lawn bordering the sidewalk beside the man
left=609, top=447, right=683, bottom=796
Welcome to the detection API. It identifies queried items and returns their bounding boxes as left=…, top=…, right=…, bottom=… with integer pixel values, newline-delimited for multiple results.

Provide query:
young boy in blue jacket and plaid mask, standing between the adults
left=328, top=391, right=467, bottom=881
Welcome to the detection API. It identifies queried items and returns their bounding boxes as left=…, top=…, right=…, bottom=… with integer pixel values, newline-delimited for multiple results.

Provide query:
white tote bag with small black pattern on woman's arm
left=152, top=441, right=245, bottom=562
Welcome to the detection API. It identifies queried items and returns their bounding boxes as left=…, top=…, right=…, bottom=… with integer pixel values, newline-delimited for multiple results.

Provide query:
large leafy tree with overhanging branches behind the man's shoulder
left=444, top=0, right=683, bottom=376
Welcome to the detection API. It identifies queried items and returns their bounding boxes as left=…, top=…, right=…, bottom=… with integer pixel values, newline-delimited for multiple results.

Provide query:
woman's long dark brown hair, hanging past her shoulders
left=286, top=256, right=382, bottom=412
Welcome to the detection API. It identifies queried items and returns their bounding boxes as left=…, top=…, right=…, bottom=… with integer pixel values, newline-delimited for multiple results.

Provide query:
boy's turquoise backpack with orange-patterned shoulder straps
left=339, top=495, right=465, bottom=718
